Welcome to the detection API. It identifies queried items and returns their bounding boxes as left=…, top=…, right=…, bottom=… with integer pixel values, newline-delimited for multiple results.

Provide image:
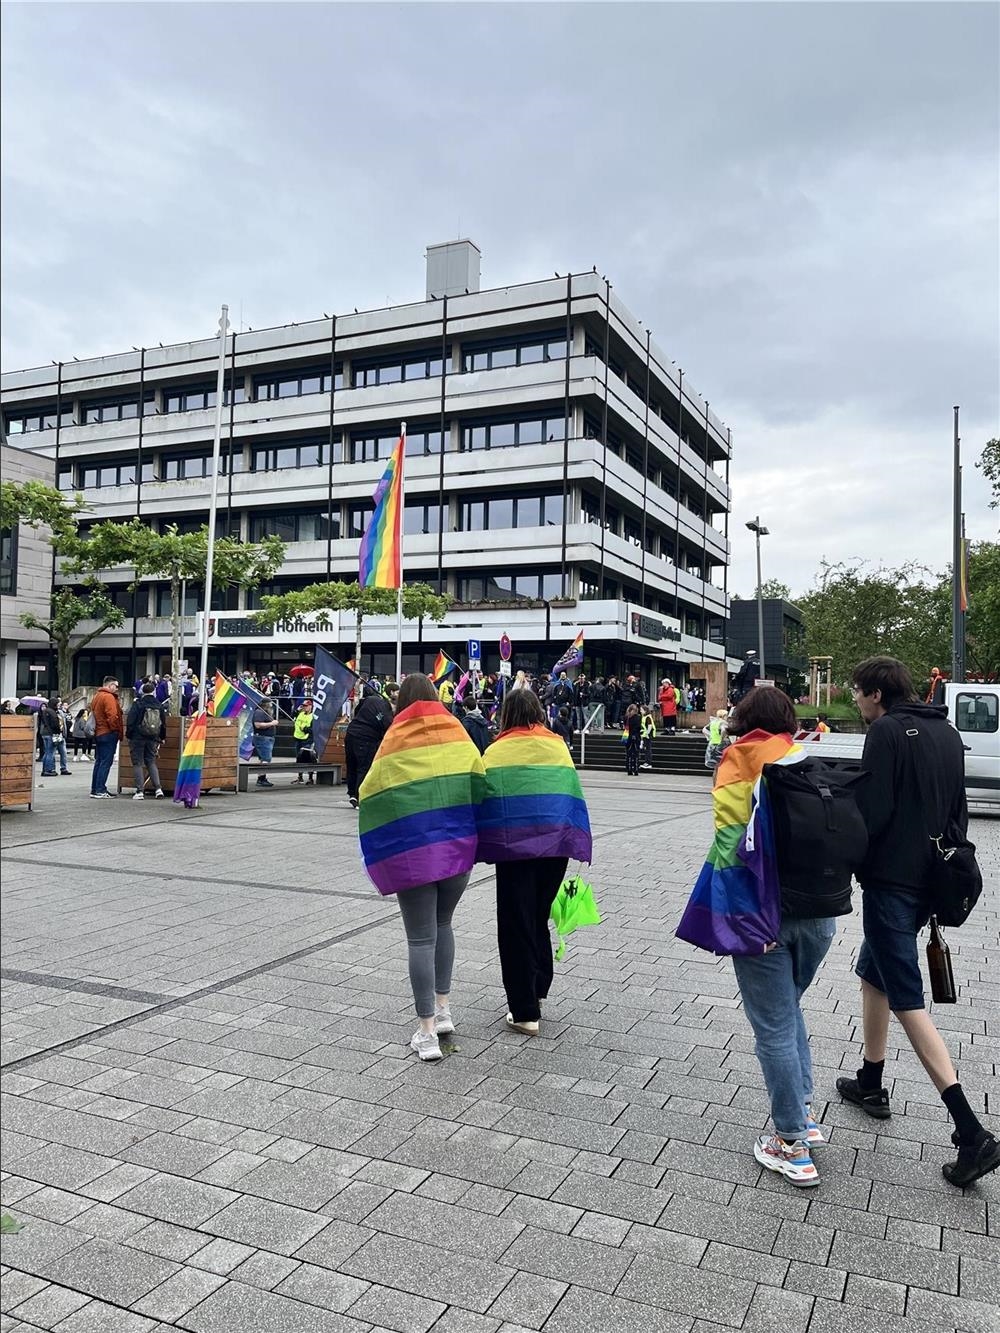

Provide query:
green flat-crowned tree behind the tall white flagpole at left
left=59, top=519, right=285, bottom=708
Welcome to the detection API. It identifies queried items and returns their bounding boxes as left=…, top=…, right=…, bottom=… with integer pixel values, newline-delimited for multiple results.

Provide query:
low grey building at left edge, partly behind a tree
left=0, top=444, right=56, bottom=698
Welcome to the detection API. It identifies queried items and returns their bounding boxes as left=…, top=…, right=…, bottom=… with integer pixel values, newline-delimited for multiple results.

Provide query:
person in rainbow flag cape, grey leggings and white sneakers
left=359, top=673, right=484, bottom=1060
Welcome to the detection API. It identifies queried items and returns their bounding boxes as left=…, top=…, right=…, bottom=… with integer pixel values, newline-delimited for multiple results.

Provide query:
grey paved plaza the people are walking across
left=0, top=764, right=1000, bottom=1333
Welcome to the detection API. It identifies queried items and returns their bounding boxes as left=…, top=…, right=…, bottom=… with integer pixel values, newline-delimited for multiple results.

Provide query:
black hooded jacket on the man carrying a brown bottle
left=857, top=704, right=969, bottom=890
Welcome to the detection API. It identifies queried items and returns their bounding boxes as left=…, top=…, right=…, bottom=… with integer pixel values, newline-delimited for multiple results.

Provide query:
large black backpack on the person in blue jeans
left=764, top=756, right=871, bottom=917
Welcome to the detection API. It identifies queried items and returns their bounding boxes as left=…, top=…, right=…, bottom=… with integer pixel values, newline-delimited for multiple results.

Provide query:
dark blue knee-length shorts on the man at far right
left=855, top=885, right=931, bottom=1013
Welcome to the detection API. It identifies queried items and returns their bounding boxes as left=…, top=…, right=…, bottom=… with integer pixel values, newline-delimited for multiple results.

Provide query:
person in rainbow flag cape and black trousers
left=476, top=689, right=592, bottom=1036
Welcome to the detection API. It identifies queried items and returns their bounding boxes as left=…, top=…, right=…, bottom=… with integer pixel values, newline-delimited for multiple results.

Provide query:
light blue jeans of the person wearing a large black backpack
left=732, top=917, right=837, bottom=1141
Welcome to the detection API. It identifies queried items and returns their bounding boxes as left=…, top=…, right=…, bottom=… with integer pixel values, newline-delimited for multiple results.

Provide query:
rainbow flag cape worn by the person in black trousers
left=476, top=725, right=592, bottom=865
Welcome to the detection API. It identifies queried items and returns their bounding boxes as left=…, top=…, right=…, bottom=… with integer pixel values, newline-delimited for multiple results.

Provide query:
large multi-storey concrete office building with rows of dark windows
left=3, top=247, right=731, bottom=681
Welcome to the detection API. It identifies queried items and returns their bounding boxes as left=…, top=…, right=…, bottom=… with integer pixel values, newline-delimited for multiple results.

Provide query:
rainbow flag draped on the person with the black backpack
left=676, top=732, right=803, bottom=956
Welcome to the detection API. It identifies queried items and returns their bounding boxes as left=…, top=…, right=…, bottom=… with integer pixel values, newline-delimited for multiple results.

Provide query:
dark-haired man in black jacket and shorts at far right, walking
left=842, top=657, right=1000, bottom=1188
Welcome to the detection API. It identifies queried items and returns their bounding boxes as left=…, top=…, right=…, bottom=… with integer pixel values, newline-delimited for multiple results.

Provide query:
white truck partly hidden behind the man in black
left=795, top=684, right=1000, bottom=814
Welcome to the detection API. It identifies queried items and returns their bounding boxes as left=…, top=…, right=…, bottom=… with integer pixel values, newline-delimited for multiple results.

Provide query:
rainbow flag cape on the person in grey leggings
left=357, top=700, right=488, bottom=896
